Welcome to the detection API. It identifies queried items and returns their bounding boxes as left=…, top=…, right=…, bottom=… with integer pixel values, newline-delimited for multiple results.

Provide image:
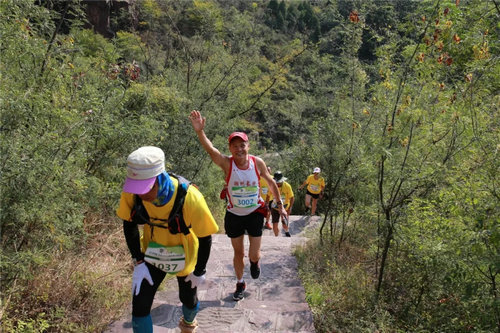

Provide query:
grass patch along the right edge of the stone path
left=295, top=228, right=397, bottom=333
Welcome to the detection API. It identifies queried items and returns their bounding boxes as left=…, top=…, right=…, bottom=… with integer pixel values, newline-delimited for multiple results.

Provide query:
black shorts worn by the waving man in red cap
left=224, top=211, right=264, bottom=238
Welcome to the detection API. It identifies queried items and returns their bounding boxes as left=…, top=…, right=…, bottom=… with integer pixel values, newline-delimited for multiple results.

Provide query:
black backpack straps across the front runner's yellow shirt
left=130, top=173, right=191, bottom=235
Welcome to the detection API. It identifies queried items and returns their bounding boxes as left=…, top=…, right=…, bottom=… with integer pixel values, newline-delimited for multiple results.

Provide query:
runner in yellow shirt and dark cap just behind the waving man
left=268, top=171, right=295, bottom=237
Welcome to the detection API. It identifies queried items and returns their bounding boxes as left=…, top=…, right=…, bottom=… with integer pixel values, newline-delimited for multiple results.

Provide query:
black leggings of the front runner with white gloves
left=132, top=263, right=198, bottom=317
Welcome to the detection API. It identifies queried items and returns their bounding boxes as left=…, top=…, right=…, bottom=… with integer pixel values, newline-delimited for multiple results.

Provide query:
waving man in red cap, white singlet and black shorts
left=189, top=110, right=286, bottom=301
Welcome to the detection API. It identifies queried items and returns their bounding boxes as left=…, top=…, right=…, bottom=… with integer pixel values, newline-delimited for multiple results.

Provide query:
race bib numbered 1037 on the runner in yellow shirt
left=144, top=242, right=186, bottom=274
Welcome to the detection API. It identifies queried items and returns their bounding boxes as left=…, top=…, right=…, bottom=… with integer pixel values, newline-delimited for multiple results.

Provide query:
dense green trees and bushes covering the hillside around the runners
left=0, top=0, right=500, bottom=332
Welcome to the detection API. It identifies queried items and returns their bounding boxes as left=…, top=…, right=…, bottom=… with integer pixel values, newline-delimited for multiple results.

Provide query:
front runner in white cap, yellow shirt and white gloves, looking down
left=116, top=146, right=219, bottom=332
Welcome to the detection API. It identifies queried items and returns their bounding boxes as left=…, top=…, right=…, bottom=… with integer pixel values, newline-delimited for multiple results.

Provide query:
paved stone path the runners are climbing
left=106, top=216, right=320, bottom=333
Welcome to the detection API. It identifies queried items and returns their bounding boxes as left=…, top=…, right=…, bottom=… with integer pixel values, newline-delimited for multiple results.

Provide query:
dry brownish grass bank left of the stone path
left=1, top=215, right=132, bottom=332
